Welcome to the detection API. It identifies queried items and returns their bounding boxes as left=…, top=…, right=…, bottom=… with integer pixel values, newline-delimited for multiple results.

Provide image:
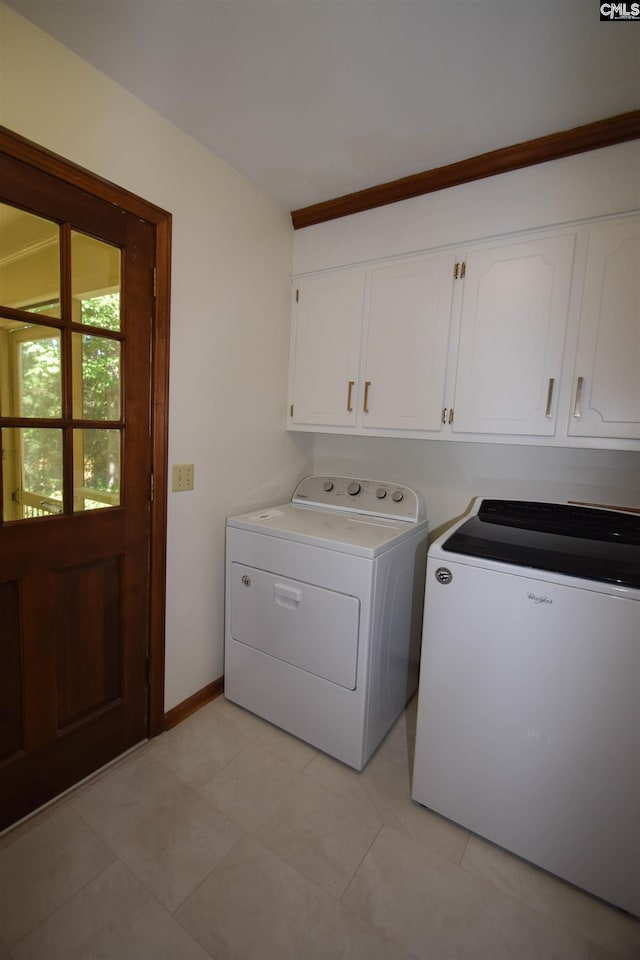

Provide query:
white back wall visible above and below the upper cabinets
left=293, top=141, right=640, bottom=530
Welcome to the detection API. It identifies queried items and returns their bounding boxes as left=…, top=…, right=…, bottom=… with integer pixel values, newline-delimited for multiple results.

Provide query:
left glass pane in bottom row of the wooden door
left=1, top=427, right=62, bottom=520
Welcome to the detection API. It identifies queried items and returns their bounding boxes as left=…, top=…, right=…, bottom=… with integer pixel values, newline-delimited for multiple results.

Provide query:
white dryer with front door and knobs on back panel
left=224, top=476, right=428, bottom=770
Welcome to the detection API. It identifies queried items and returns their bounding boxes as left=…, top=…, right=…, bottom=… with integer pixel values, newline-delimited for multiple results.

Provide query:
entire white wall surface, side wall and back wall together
left=0, top=4, right=640, bottom=709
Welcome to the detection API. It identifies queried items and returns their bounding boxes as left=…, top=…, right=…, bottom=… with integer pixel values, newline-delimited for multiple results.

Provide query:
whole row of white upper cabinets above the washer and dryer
left=287, top=213, right=640, bottom=449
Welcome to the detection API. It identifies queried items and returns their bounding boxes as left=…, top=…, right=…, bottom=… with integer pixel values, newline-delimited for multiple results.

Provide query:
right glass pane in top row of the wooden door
left=71, top=230, right=121, bottom=330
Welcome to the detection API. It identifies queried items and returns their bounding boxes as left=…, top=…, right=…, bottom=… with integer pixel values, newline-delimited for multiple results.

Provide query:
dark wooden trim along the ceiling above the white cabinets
left=291, top=110, right=640, bottom=230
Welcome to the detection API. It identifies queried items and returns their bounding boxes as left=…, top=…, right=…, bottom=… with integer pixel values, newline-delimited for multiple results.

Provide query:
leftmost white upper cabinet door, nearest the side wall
left=289, top=270, right=365, bottom=426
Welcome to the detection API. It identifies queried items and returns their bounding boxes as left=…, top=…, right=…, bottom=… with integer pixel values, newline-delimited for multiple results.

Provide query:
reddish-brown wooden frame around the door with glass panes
left=0, top=126, right=172, bottom=736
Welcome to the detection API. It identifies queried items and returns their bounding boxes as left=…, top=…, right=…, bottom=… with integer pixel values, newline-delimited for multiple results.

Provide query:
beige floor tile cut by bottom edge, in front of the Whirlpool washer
left=343, top=827, right=589, bottom=960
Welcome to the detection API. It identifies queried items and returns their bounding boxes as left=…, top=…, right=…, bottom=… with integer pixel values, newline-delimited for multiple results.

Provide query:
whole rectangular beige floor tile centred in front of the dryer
left=201, top=746, right=382, bottom=898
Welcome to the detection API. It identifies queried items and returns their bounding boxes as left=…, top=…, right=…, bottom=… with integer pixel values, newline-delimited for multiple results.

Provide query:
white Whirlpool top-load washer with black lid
left=413, top=499, right=640, bottom=915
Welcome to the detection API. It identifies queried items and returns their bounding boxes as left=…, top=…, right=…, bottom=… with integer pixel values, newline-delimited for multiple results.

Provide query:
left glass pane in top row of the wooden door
left=0, top=203, right=60, bottom=317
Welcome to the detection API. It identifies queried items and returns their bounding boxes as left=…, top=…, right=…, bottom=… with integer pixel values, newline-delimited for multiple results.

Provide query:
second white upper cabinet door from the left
left=362, top=255, right=455, bottom=430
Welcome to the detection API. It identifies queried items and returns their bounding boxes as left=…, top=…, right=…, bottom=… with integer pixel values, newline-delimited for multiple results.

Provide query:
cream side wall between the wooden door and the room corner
left=0, top=5, right=312, bottom=710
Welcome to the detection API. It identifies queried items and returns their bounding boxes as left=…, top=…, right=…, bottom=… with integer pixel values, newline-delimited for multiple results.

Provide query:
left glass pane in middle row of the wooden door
left=0, top=317, right=62, bottom=418
